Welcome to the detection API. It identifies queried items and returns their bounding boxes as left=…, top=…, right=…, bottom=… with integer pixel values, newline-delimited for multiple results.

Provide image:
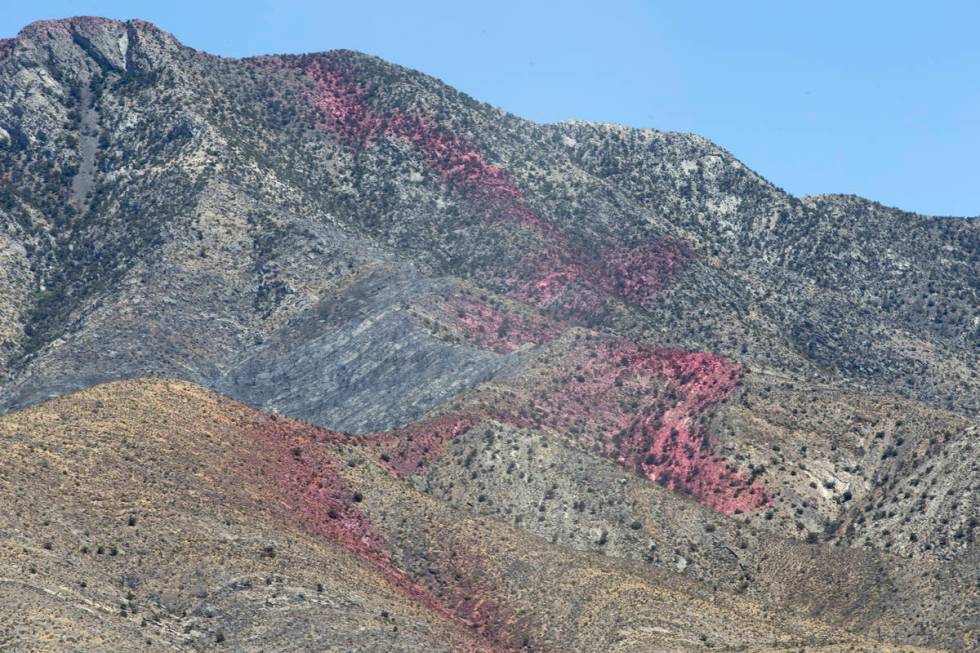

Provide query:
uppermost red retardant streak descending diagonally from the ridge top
left=255, top=54, right=690, bottom=312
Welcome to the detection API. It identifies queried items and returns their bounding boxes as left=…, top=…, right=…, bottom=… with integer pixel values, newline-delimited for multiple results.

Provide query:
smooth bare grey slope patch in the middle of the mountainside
left=215, top=268, right=507, bottom=432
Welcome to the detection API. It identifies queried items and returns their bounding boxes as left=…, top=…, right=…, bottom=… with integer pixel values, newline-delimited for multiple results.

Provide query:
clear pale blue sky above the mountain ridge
left=0, top=0, right=980, bottom=216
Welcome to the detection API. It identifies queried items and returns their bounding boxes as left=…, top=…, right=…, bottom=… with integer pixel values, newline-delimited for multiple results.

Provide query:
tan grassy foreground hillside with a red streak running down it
left=0, top=380, right=952, bottom=651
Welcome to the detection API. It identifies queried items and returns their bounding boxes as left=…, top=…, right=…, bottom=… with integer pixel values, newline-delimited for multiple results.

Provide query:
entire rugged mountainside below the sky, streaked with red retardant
left=0, top=18, right=980, bottom=651
